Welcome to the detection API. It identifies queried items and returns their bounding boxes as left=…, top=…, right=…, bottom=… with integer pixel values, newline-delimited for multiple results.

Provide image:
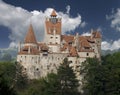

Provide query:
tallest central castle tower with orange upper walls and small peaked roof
left=45, top=10, right=61, bottom=52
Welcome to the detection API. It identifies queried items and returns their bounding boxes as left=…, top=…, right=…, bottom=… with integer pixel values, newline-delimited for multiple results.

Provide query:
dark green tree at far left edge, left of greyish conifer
left=0, top=62, right=15, bottom=95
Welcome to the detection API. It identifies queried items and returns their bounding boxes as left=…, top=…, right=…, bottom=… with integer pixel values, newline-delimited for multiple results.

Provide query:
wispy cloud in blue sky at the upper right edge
left=106, top=8, right=120, bottom=32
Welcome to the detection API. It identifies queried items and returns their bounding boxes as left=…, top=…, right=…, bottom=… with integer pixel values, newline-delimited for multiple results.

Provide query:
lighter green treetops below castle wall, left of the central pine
left=27, top=73, right=59, bottom=95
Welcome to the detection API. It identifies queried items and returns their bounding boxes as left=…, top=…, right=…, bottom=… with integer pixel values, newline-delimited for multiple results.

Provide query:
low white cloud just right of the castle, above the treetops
left=101, top=39, right=120, bottom=50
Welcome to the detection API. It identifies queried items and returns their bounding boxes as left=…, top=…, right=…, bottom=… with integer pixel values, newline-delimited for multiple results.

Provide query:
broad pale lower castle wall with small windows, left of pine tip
left=17, top=53, right=68, bottom=79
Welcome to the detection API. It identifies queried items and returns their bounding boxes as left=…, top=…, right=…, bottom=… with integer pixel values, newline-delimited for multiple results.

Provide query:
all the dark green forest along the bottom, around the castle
left=0, top=52, right=120, bottom=95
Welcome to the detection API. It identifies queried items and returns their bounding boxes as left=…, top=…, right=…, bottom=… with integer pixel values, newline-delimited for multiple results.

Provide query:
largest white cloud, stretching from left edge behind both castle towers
left=0, top=0, right=81, bottom=47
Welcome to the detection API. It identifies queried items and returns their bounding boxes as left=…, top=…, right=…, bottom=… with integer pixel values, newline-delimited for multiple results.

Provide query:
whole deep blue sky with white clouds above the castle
left=0, top=0, right=120, bottom=50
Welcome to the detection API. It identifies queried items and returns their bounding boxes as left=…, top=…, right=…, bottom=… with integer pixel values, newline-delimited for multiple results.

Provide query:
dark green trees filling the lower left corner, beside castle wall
left=0, top=62, right=28, bottom=95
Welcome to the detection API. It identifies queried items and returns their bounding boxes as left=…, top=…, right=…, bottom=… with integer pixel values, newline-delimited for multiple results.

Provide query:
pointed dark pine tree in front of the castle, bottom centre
left=57, top=58, right=79, bottom=95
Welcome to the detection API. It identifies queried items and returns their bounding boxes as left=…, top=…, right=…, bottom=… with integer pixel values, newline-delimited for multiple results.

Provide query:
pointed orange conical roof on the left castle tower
left=24, top=24, right=37, bottom=43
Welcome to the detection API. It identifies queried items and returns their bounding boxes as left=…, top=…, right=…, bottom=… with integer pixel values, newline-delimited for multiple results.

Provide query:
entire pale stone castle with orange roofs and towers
left=17, top=10, right=101, bottom=80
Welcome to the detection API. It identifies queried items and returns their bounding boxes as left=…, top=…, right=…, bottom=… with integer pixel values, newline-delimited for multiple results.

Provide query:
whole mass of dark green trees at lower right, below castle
left=82, top=53, right=120, bottom=95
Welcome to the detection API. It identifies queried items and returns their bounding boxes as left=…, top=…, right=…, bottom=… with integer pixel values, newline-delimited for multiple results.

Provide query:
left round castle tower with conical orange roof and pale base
left=17, top=24, right=40, bottom=79
